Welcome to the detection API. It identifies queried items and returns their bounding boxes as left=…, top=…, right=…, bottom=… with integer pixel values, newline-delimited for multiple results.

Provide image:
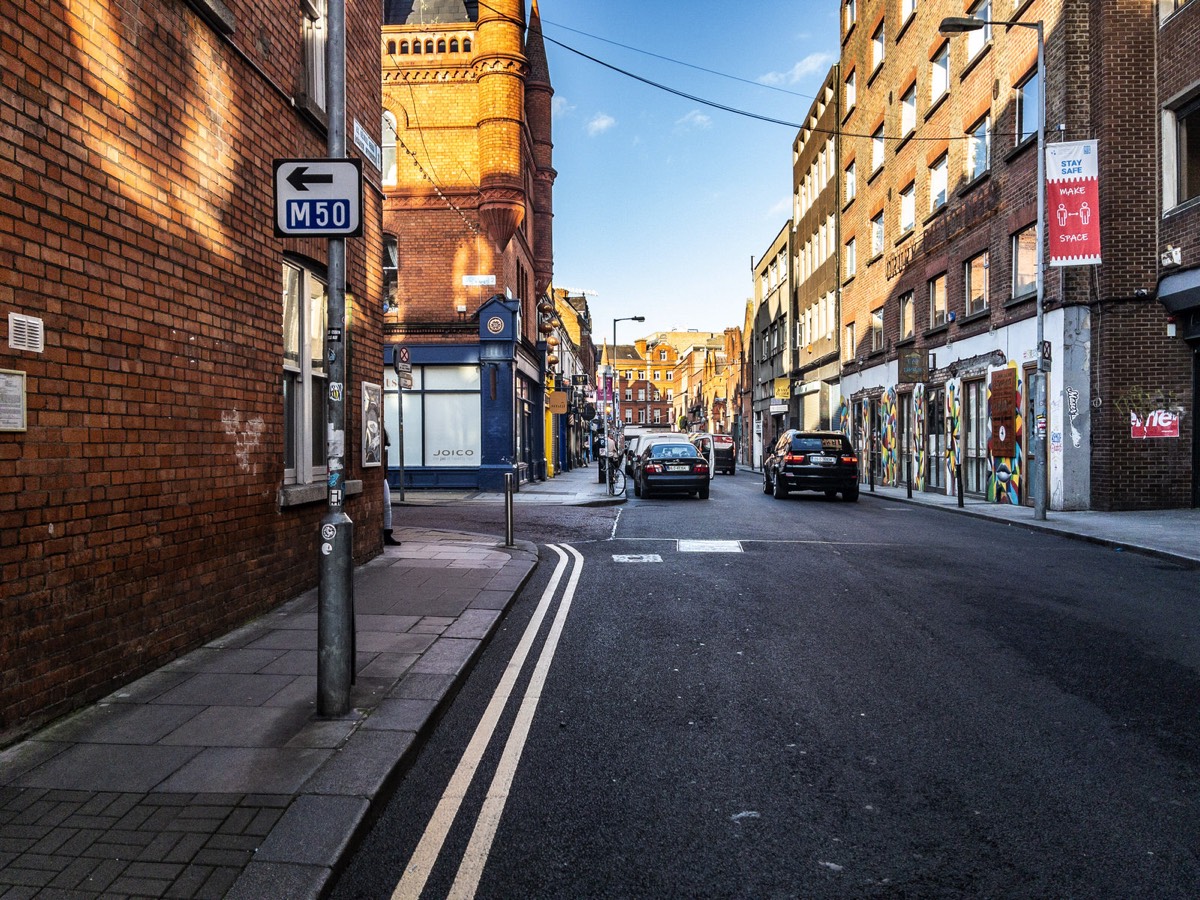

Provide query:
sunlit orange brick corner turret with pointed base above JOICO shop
left=474, top=0, right=528, bottom=251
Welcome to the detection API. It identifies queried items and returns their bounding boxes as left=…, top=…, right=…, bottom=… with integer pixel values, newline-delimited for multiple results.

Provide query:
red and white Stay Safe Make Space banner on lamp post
left=1046, top=140, right=1100, bottom=266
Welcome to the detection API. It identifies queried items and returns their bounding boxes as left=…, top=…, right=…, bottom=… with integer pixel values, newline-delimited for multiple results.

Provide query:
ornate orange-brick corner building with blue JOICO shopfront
left=383, top=0, right=556, bottom=490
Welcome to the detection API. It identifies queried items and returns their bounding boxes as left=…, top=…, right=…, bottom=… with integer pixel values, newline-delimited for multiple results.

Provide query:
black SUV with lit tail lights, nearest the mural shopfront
left=762, top=430, right=858, bottom=502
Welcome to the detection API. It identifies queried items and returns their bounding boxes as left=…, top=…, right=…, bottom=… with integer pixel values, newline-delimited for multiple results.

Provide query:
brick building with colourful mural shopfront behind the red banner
left=840, top=0, right=1195, bottom=509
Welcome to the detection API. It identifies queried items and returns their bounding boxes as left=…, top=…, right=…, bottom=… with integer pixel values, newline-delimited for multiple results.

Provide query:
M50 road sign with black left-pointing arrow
left=275, top=158, right=362, bottom=238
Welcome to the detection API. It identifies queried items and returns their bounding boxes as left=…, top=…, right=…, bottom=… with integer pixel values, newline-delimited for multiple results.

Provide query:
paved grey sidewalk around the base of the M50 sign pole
left=0, top=529, right=538, bottom=900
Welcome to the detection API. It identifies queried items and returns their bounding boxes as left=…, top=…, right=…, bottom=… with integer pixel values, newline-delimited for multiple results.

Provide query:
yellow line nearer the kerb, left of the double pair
left=391, top=544, right=568, bottom=900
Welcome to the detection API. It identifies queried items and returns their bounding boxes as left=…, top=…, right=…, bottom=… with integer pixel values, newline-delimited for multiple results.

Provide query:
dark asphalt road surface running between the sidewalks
left=334, top=473, right=1200, bottom=898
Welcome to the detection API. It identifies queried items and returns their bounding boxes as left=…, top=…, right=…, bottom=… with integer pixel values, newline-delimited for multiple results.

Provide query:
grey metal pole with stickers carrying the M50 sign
left=317, top=0, right=354, bottom=715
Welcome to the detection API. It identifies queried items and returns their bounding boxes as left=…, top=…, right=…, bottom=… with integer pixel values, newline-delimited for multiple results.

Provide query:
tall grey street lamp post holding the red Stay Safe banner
left=937, top=16, right=1046, bottom=521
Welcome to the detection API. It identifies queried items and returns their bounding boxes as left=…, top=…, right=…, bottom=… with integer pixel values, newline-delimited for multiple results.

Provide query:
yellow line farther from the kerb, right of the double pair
left=449, top=544, right=583, bottom=900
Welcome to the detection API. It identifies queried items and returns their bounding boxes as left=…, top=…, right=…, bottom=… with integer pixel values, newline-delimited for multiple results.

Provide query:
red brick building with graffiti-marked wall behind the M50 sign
left=0, top=0, right=383, bottom=743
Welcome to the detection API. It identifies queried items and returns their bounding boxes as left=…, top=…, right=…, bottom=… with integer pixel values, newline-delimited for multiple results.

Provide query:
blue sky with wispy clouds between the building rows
left=539, top=0, right=839, bottom=344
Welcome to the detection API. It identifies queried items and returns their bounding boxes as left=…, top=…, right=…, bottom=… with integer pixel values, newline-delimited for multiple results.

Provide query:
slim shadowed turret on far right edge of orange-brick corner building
left=526, top=0, right=558, bottom=296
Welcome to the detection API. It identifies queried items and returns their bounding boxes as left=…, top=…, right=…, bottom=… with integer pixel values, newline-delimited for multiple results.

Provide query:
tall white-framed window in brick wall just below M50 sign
left=283, top=260, right=329, bottom=485
